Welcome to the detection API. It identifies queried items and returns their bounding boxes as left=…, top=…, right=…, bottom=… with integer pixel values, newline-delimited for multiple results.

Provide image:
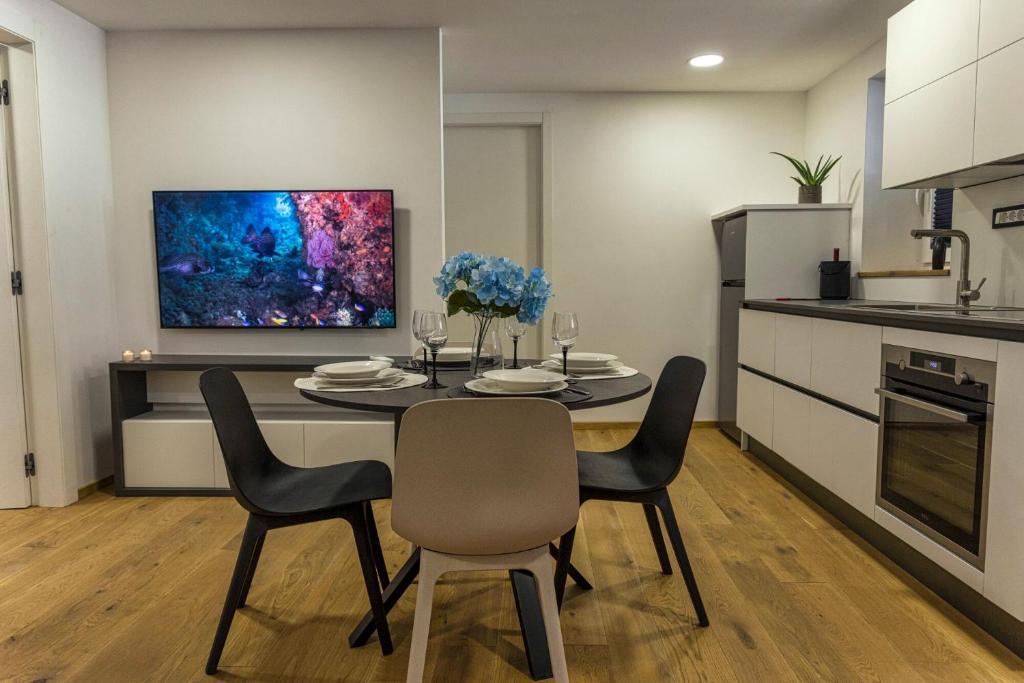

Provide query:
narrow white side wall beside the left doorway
left=0, top=0, right=117, bottom=505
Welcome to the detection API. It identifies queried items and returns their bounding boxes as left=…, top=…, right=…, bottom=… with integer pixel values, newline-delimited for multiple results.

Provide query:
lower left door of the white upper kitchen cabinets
left=882, top=64, right=977, bottom=188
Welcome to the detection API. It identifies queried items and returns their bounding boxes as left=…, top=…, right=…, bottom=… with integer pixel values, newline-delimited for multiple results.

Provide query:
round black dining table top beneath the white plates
left=299, top=361, right=651, bottom=415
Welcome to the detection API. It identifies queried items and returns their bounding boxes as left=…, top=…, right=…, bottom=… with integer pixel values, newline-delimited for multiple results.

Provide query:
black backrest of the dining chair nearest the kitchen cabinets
left=631, top=355, right=708, bottom=485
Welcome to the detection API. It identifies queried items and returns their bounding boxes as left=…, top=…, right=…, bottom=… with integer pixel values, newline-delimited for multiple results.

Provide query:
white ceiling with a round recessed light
left=51, top=0, right=909, bottom=92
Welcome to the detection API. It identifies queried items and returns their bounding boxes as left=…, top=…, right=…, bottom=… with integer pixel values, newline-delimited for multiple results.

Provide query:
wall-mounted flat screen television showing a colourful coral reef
left=153, top=189, right=395, bottom=329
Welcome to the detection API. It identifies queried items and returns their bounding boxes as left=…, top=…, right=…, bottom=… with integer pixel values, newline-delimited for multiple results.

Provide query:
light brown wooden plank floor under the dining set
left=0, top=429, right=1024, bottom=683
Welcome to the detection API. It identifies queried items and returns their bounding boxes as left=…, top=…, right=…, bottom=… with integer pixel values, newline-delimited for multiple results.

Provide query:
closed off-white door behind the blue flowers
left=444, top=125, right=546, bottom=358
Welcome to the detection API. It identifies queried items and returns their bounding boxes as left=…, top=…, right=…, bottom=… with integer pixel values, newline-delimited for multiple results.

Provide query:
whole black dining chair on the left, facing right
left=199, top=368, right=393, bottom=675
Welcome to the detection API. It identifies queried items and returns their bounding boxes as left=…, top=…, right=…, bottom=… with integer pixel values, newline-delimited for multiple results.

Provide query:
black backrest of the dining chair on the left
left=199, top=368, right=287, bottom=513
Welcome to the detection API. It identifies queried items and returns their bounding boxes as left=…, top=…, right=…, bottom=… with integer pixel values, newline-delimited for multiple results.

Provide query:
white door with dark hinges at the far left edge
left=0, top=48, right=32, bottom=508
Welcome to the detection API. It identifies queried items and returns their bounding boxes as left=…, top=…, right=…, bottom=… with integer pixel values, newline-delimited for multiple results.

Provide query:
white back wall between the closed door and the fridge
left=444, top=93, right=805, bottom=420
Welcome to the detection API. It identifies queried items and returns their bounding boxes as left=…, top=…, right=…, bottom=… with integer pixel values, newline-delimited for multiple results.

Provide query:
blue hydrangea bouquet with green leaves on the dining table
left=434, top=252, right=551, bottom=376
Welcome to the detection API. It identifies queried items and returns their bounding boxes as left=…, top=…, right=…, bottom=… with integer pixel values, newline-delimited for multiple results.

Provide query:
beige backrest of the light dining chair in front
left=391, top=398, right=580, bottom=555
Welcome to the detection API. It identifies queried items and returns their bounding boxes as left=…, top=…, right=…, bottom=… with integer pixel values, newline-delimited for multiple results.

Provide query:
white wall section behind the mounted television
left=108, top=29, right=443, bottom=354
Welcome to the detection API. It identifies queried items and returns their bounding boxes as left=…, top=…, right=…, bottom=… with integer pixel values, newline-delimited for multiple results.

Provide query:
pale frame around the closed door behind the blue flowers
left=441, top=112, right=555, bottom=348
